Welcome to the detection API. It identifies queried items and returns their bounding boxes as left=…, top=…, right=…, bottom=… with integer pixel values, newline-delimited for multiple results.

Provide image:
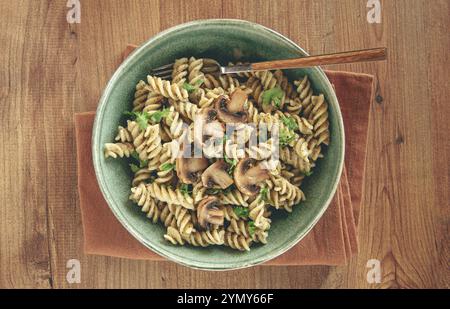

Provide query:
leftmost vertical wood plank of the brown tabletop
left=0, top=2, right=51, bottom=288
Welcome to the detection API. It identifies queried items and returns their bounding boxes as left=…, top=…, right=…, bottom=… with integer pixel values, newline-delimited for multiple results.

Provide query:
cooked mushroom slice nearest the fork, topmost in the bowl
left=214, top=88, right=248, bottom=123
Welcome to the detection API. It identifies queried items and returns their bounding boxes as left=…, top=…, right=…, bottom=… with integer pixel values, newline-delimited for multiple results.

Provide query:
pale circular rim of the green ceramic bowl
left=91, top=18, right=345, bottom=271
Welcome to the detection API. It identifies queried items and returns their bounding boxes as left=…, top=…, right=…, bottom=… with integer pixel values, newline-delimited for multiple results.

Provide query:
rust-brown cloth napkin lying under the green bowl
left=75, top=45, right=374, bottom=265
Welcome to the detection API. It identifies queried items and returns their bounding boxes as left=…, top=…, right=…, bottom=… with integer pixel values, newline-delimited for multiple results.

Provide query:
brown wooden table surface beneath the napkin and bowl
left=0, top=0, right=450, bottom=288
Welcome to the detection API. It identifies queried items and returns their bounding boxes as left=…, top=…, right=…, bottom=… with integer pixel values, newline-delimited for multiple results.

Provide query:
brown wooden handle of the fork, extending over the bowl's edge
left=252, top=47, right=387, bottom=71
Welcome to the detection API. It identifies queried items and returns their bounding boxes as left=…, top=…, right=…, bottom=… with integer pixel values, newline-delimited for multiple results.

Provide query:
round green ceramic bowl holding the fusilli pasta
left=92, top=19, right=344, bottom=270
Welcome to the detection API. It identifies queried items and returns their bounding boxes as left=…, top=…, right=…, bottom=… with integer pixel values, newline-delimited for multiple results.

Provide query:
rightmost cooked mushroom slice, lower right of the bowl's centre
left=234, top=158, right=269, bottom=196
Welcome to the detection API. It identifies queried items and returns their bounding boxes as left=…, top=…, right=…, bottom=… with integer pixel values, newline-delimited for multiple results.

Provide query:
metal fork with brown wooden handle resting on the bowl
left=151, top=47, right=387, bottom=79
